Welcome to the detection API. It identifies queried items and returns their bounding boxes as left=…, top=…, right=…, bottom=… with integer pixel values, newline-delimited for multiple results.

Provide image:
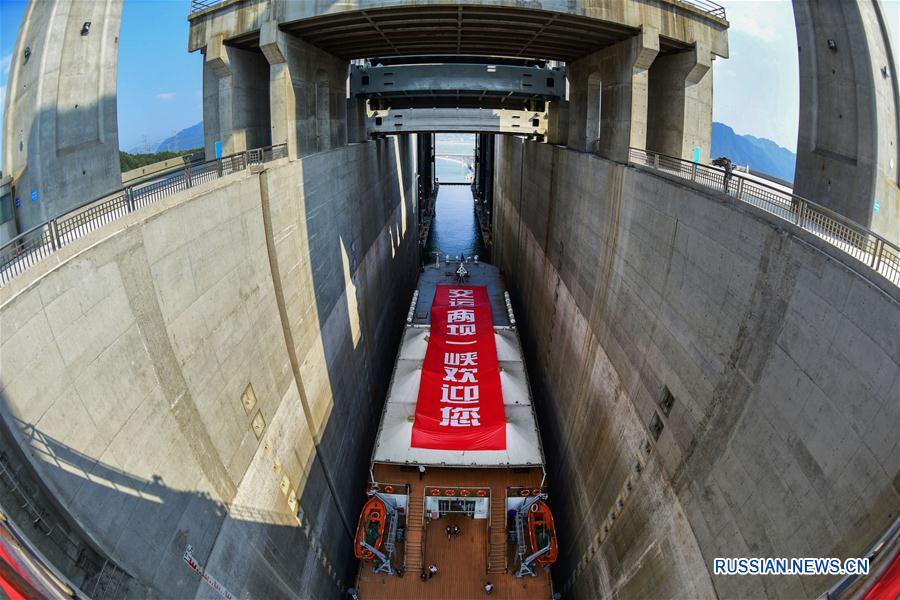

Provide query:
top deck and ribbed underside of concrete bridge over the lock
left=188, top=0, right=728, bottom=62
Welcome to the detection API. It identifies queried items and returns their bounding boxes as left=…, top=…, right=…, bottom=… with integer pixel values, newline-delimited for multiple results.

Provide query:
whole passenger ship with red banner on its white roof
left=354, top=256, right=559, bottom=600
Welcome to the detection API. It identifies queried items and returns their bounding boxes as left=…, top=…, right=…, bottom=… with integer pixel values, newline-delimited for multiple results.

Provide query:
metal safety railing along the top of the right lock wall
left=628, top=148, right=900, bottom=285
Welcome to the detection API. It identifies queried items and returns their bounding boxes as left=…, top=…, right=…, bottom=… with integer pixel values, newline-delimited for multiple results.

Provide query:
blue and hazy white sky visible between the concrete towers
left=0, top=0, right=900, bottom=159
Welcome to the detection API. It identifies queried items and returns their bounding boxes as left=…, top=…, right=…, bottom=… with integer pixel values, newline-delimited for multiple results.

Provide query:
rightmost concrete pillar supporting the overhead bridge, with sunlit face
left=647, top=44, right=713, bottom=163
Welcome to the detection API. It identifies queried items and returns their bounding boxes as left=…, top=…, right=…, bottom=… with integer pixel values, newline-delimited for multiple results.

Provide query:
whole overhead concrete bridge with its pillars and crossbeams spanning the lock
left=188, top=0, right=728, bottom=161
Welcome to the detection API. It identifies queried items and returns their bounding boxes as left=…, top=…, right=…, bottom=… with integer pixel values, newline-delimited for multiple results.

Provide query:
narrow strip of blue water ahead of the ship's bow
left=423, top=185, right=489, bottom=261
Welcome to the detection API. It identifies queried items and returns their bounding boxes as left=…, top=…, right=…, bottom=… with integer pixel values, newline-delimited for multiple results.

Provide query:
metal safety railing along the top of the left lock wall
left=0, top=144, right=287, bottom=287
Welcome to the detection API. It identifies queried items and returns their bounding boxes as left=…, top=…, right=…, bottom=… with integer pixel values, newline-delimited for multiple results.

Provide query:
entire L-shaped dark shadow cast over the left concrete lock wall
left=0, top=138, right=416, bottom=598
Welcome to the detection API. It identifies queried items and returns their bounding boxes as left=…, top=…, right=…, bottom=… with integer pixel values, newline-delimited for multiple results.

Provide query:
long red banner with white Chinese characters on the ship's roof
left=410, top=285, right=506, bottom=450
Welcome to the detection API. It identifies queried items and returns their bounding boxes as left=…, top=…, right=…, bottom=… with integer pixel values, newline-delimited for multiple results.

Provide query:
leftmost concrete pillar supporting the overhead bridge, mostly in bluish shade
left=203, top=35, right=272, bottom=158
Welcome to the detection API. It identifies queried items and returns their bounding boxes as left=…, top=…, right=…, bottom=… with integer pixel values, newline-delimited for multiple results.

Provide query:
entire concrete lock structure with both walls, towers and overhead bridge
left=0, top=0, right=900, bottom=598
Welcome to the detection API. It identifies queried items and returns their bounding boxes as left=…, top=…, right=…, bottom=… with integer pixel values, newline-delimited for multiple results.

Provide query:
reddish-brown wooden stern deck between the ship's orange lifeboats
left=356, top=465, right=551, bottom=600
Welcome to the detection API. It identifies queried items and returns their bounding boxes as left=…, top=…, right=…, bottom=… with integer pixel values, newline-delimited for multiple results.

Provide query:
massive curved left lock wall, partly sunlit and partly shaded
left=0, top=138, right=416, bottom=598
